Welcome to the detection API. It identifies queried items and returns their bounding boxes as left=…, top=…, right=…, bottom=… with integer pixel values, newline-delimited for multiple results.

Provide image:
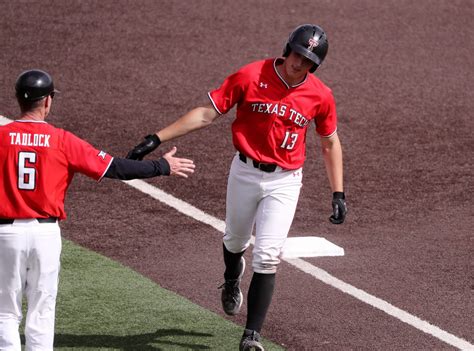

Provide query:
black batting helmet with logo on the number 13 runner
left=283, top=24, right=329, bottom=73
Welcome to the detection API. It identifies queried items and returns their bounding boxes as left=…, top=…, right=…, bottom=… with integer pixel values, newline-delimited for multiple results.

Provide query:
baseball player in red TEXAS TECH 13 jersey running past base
left=127, top=24, right=347, bottom=350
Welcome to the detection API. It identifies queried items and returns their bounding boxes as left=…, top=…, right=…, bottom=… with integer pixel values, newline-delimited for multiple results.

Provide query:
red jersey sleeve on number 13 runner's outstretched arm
left=208, top=71, right=246, bottom=115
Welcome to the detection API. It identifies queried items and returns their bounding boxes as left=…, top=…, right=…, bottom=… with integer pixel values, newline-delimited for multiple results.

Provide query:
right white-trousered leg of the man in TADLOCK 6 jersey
left=25, top=223, right=61, bottom=351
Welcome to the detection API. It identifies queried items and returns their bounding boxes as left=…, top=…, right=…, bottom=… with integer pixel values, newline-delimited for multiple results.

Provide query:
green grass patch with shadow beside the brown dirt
left=20, top=240, right=283, bottom=351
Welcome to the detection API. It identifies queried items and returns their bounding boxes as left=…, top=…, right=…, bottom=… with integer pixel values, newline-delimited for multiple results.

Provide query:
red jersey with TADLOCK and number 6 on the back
left=0, top=120, right=112, bottom=219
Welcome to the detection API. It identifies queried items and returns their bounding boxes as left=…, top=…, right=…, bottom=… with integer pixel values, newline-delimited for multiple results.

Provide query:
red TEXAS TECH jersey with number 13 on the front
left=208, top=59, right=337, bottom=169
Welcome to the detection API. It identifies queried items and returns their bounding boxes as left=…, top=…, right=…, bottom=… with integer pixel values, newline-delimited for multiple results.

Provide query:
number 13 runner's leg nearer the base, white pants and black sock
left=243, top=172, right=301, bottom=350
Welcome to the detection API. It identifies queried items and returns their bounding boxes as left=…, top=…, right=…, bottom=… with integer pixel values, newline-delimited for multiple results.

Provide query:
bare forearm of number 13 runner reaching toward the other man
left=156, top=106, right=218, bottom=142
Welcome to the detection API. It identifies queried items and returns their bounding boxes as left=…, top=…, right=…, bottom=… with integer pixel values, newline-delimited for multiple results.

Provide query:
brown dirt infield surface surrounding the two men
left=0, top=0, right=474, bottom=350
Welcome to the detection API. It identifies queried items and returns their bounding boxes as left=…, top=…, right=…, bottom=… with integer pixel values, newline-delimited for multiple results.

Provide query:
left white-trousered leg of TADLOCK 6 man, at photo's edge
left=0, top=225, right=26, bottom=351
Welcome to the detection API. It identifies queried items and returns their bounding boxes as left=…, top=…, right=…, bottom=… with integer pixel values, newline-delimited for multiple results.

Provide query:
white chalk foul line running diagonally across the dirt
left=0, top=116, right=474, bottom=350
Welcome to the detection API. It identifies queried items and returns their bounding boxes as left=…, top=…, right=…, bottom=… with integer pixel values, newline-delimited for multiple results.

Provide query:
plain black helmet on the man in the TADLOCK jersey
left=15, top=69, right=58, bottom=101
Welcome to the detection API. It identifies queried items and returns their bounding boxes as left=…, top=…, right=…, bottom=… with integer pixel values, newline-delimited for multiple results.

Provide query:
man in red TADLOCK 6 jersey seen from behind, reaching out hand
left=0, top=70, right=194, bottom=351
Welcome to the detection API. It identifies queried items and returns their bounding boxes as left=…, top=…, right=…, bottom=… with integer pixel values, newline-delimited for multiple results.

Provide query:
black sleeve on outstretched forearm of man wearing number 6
left=104, top=158, right=171, bottom=180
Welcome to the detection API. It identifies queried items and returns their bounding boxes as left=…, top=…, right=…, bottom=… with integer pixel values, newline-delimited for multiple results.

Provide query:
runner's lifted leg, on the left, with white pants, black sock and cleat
left=221, top=157, right=261, bottom=315
